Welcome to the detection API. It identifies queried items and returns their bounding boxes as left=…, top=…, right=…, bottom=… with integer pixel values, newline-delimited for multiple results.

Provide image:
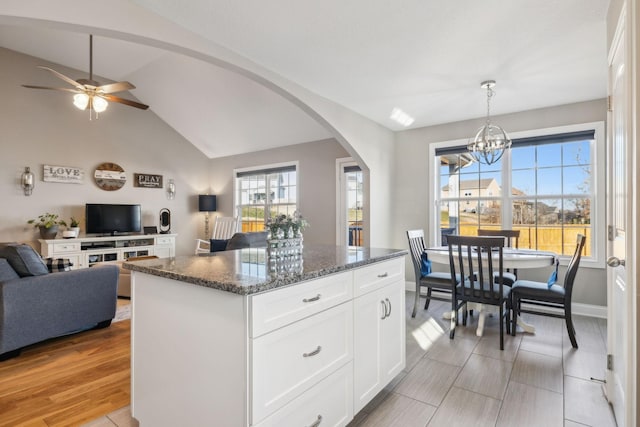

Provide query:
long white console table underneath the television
left=39, top=234, right=177, bottom=269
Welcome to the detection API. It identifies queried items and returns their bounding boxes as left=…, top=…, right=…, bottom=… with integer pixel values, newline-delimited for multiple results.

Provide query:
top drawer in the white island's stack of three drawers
left=251, top=272, right=353, bottom=338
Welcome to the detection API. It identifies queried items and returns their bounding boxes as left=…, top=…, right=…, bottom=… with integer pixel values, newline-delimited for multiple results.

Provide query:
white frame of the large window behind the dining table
left=426, top=121, right=606, bottom=268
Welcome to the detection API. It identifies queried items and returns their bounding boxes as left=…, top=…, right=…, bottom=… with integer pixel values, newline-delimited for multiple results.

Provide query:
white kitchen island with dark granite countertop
left=123, top=245, right=407, bottom=427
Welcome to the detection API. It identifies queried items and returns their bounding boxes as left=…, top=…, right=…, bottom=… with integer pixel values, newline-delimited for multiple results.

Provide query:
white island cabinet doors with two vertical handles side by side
left=353, top=270, right=405, bottom=413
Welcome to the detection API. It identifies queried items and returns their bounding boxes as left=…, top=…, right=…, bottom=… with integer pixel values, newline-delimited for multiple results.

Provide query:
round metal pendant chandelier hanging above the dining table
left=467, top=80, right=511, bottom=165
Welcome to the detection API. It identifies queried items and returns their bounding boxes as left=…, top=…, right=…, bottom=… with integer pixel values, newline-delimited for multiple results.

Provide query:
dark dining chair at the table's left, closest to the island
left=407, top=230, right=452, bottom=317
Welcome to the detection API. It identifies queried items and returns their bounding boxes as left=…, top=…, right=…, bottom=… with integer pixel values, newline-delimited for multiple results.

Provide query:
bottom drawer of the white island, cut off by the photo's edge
left=256, top=362, right=353, bottom=427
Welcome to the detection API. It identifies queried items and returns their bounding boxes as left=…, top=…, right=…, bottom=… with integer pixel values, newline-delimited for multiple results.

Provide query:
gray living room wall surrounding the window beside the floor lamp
left=211, top=139, right=349, bottom=245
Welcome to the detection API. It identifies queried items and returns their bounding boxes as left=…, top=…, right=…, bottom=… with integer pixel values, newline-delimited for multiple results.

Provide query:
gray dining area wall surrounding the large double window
left=392, top=99, right=607, bottom=306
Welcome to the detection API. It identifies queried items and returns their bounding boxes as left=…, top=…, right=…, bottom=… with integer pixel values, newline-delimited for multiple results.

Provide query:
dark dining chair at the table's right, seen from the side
left=511, top=234, right=587, bottom=348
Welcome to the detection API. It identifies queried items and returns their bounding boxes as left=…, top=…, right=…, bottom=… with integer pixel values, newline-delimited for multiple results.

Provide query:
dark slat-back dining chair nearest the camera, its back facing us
left=447, top=235, right=511, bottom=350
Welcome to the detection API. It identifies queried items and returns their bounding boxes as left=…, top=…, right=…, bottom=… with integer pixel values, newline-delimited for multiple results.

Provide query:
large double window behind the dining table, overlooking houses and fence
left=430, top=123, right=605, bottom=262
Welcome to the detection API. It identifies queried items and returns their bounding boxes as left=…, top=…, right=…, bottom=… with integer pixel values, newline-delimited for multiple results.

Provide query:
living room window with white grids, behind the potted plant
left=234, top=163, right=298, bottom=232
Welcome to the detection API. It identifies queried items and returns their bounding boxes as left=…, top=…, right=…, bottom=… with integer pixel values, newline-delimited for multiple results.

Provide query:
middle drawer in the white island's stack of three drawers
left=250, top=301, right=353, bottom=424
